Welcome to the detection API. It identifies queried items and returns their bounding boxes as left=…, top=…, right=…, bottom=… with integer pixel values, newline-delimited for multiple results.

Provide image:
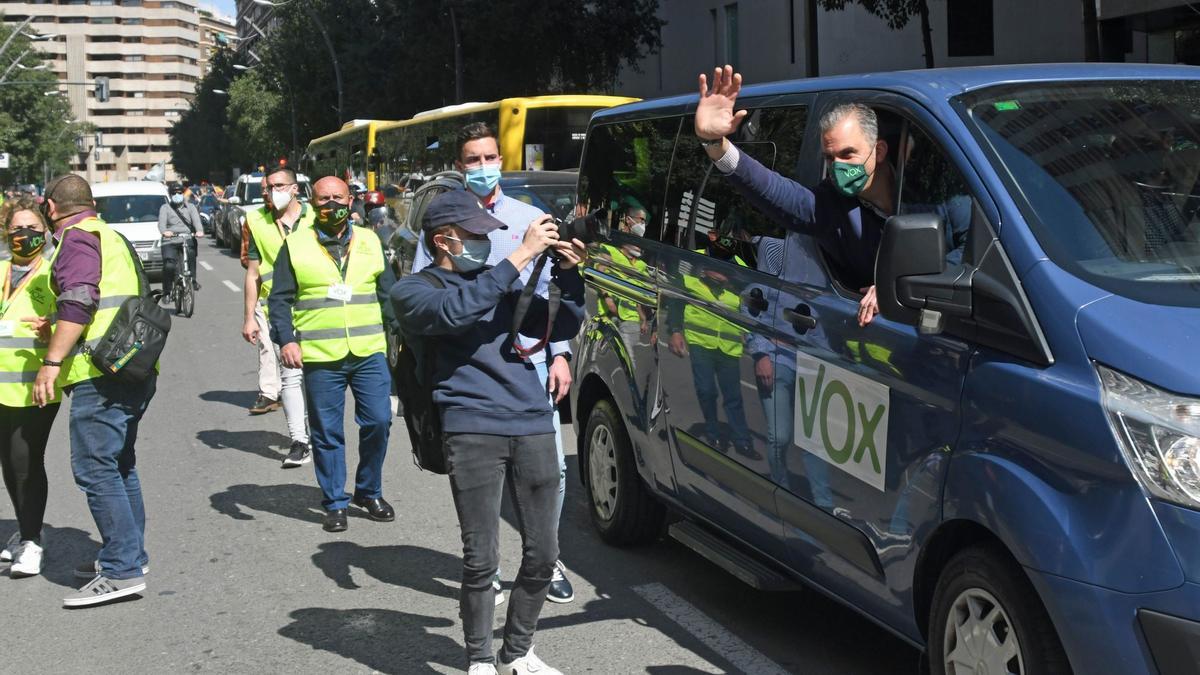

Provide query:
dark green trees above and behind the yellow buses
left=212, top=0, right=661, bottom=167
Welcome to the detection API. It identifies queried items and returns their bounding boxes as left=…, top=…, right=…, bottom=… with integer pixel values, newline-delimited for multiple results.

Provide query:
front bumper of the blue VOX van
left=1025, top=568, right=1200, bottom=675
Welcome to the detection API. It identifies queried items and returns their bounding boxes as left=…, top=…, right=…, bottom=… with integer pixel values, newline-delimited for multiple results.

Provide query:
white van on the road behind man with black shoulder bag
left=91, top=180, right=167, bottom=279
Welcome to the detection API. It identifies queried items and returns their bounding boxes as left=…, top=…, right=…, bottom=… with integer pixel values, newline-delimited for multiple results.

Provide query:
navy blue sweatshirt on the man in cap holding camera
left=391, top=259, right=583, bottom=436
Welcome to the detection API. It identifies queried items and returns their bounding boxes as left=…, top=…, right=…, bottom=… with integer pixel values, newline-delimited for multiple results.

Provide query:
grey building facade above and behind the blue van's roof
left=617, top=0, right=1200, bottom=97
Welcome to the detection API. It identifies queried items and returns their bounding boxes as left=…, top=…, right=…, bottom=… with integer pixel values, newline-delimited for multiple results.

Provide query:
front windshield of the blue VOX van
left=958, top=80, right=1200, bottom=306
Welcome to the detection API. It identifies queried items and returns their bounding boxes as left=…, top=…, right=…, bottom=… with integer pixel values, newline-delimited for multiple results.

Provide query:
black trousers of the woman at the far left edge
left=0, top=404, right=59, bottom=542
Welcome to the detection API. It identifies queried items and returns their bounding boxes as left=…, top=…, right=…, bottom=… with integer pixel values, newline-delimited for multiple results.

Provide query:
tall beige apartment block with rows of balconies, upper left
left=0, top=0, right=200, bottom=181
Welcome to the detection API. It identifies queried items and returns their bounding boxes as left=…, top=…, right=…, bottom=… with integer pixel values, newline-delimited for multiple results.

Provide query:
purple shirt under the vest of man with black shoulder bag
left=50, top=211, right=101, bottom=325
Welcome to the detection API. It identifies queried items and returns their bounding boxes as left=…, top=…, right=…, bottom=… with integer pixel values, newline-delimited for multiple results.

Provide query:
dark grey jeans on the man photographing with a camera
left=445, top=434, right=558, bottom=663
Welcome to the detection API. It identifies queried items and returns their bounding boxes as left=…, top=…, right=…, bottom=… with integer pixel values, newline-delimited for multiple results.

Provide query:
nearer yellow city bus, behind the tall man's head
left=374, top=95, right=637, bottom=192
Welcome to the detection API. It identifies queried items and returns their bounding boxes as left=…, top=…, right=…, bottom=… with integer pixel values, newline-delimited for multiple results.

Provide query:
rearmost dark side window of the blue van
left=578, top=118, right=679, bottom=239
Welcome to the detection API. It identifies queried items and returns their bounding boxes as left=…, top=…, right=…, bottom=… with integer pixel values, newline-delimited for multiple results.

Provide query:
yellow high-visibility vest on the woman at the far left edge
left=0, top=257, right=60, bottom=408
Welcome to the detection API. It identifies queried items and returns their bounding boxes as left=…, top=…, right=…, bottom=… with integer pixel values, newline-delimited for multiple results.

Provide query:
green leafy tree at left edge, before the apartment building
left=0, top=18, right=89, bottom=185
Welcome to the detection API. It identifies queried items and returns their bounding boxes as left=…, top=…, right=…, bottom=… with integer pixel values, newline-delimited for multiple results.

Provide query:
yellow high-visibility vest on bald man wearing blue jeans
left=287, top=226, right=388, bottom=363
